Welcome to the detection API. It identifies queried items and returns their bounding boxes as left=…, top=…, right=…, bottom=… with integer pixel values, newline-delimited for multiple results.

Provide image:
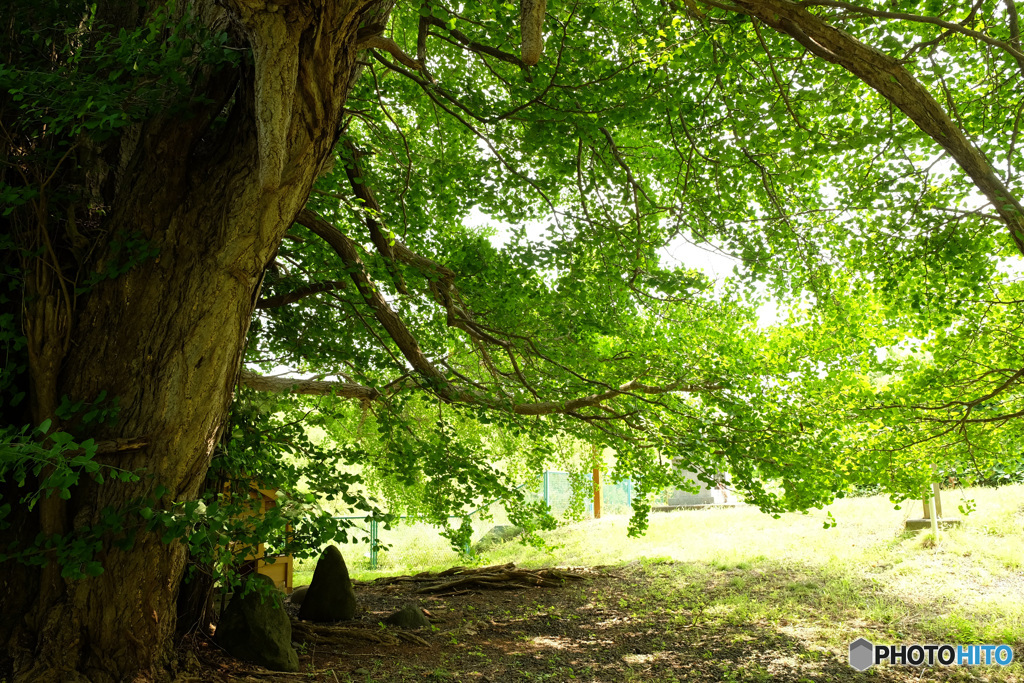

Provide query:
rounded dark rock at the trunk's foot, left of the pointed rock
left=216, top=574, right=299, bottom=671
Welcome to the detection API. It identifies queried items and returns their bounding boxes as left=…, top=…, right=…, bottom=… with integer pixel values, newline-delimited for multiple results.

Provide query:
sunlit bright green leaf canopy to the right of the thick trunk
left=256, top=3, right=1020, bottom=532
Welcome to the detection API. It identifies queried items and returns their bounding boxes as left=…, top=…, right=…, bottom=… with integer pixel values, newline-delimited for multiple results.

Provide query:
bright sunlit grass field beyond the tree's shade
left=481, top=485, right=1024, bottom=663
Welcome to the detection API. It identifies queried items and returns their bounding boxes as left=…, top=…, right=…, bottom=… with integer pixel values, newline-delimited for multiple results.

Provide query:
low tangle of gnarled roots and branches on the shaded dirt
left=373, top=562, right=584, bottom=594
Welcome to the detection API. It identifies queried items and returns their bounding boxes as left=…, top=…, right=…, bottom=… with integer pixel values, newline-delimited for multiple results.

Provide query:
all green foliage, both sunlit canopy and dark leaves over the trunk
left=0, top=0, right=1024, bottom=571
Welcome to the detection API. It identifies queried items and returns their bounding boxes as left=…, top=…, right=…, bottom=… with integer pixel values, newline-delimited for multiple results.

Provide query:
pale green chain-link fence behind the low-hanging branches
left=294, top=472, right=633, bottom=585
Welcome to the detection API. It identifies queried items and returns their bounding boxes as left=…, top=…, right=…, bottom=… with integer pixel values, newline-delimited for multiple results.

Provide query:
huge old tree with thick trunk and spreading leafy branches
left=0, top=0, right=1024, bottom=681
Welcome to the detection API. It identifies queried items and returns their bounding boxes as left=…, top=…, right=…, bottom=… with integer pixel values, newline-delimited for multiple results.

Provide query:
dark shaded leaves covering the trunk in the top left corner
left=0, top=0, right=239, bottom=144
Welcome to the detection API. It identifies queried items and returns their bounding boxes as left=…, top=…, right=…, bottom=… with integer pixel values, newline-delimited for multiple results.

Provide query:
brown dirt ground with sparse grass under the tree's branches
left=178, top=563, right=995, bottom=683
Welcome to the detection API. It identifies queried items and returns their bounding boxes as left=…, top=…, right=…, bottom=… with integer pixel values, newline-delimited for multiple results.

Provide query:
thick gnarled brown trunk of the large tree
left=0, top=0, right=390, bottom=682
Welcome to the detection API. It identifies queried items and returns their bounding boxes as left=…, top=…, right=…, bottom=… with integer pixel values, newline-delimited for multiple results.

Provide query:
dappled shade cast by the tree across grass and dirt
left=209, top=560, right=1012, bottom=683
